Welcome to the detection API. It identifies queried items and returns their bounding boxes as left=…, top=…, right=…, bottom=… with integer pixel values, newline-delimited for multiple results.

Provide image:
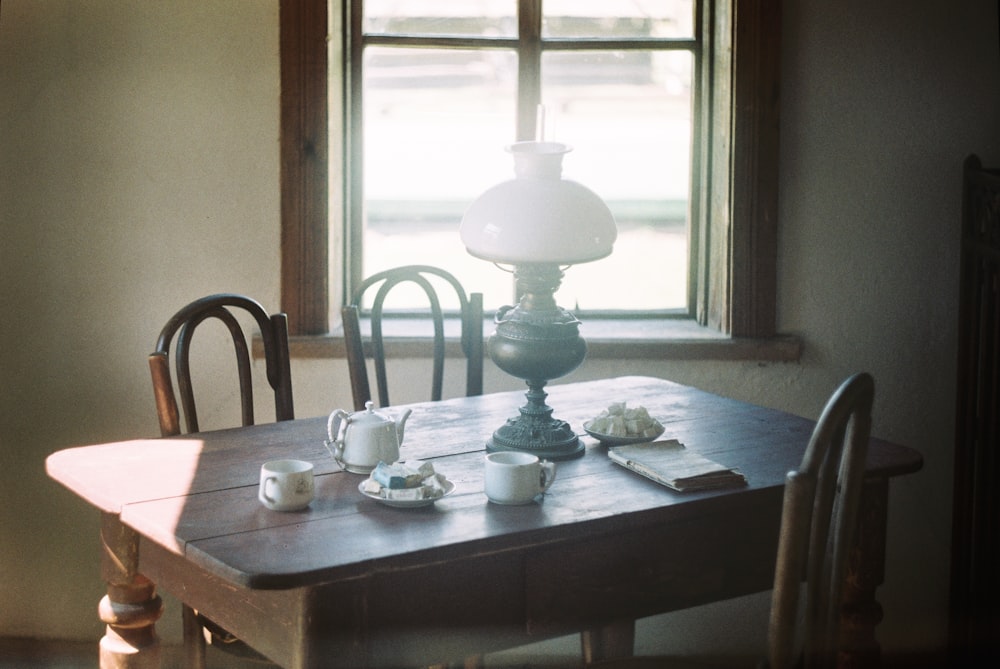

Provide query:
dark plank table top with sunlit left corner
left=46, top=376, right=922, bottom=589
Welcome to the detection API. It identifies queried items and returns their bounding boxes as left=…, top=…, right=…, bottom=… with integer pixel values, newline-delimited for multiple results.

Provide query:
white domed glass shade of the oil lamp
left=459, top=142, right=618, bottom=265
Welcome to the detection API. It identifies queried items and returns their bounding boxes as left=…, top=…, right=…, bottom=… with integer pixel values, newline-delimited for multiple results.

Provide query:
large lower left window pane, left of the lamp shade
left=363, top=47, right=517, bottom=307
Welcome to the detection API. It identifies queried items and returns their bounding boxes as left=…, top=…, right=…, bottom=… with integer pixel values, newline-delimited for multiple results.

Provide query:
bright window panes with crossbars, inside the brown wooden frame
left=358, top=0, right=701, bottom=318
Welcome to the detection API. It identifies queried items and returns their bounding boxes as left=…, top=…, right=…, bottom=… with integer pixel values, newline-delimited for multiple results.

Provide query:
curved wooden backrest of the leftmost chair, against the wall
left=149, top=294, right=295, bottom=437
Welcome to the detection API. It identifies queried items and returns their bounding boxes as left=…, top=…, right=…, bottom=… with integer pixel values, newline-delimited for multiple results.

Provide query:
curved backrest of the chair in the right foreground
left=768, top=373, right=875, bottom=669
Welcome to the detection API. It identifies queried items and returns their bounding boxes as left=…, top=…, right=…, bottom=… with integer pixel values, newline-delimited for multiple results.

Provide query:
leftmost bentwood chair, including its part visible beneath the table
left=149, top=294, right=295, bottom=669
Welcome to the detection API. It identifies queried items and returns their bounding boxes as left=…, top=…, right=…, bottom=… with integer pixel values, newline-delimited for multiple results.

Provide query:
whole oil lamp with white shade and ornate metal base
left=460, top=141, right=618, bottom=460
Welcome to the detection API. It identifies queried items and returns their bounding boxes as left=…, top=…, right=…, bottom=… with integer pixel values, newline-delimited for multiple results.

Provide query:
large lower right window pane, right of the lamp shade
left=542, top=51, right=692, bottom=311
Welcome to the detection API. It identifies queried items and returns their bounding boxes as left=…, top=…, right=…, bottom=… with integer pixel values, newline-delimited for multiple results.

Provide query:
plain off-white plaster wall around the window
left=0, top=0, right=1000, bottom=650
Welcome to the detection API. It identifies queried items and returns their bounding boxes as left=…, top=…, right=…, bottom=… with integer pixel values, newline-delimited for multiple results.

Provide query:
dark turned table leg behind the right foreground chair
left=837, top=478, right=889, bottom=669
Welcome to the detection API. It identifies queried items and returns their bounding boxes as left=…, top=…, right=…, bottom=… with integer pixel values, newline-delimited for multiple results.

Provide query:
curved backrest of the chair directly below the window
left=342, top=265, right=483, bottom=410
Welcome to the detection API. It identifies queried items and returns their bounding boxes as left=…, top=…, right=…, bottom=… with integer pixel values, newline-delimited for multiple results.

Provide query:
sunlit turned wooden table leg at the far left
left=98, top=513, right=163, bottom=669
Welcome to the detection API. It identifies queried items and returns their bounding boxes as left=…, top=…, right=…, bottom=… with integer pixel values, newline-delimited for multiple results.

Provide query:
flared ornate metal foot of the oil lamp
left=486, top=381, right=584, bottom=460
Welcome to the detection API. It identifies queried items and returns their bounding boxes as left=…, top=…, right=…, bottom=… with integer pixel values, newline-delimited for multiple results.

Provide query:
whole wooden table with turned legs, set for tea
left=47, top=377, right=922, bottom=667
